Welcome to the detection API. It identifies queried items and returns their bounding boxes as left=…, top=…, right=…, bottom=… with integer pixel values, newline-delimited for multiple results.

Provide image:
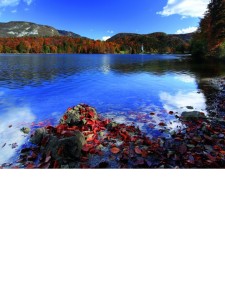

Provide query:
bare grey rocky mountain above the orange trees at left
left=0, top=21, right=81, bottom=38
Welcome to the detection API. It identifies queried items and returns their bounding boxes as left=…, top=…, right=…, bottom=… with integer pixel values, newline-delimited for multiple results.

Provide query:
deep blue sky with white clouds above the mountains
left=0, top=0, right=209, bottom=39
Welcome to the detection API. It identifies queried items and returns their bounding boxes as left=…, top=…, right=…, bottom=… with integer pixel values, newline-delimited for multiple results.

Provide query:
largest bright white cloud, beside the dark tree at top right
left=157, top=0, right=210, bottom=18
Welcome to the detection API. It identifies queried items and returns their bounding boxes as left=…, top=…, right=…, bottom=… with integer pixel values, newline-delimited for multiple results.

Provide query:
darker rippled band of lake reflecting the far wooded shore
left=0, top=54, right=225, bottom=88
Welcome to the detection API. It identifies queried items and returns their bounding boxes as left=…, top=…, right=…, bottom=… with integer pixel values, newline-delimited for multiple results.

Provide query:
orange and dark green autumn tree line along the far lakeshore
left=0, top=33, right=190, bottom=54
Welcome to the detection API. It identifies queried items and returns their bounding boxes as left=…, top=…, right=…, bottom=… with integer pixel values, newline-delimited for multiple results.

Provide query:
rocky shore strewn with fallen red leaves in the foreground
left=2, top=78, right=225, bottom=169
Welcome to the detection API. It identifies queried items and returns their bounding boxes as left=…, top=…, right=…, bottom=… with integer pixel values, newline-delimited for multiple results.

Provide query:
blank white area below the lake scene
left=0, top=170, right=225, bottom=300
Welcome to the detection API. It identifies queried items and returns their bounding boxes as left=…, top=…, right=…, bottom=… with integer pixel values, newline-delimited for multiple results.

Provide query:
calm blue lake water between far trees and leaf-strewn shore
left=0, top=55, right=225, bottom=164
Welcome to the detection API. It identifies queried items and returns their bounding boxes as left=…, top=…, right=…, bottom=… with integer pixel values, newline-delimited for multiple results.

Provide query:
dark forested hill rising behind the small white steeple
left=107, top=32, right=193, bottom=53
